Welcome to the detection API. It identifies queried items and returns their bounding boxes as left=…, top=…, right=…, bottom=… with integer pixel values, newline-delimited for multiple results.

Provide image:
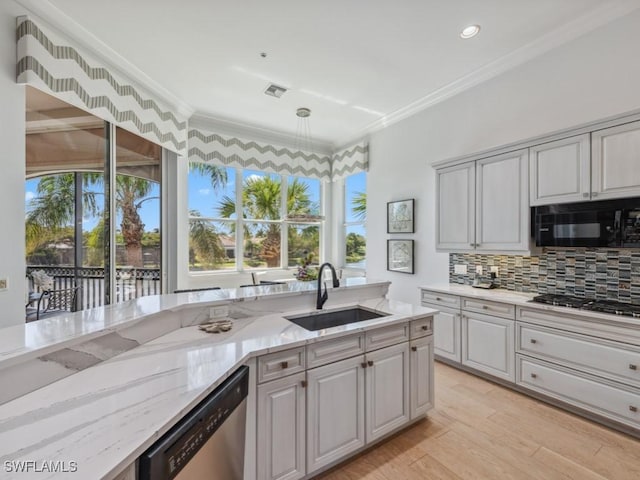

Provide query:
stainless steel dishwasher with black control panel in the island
left=138, top=367, right=249, bottom=480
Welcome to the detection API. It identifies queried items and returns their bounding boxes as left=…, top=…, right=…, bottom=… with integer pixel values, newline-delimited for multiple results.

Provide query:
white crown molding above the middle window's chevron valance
left=189, top=112, right=335, bottom=155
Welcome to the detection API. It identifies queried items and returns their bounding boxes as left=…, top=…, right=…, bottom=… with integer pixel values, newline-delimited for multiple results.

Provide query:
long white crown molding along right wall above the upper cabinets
left=335, top=0, right=640, bottom=145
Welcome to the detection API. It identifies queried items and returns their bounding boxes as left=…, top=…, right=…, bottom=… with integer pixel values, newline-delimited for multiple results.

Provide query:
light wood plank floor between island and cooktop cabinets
left=316, top=362, right=640, bottom=480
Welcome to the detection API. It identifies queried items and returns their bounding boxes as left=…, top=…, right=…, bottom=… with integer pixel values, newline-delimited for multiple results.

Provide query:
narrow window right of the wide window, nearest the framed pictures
left=344, top=172, right=367, bottom=269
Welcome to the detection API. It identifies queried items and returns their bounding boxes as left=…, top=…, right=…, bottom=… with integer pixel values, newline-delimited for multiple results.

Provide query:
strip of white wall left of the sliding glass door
left=0, top=0, right=25, bottom=327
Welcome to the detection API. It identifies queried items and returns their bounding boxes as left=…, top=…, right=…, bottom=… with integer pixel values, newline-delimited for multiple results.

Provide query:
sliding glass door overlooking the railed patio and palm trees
left=25, top=87, right=162, bottom=316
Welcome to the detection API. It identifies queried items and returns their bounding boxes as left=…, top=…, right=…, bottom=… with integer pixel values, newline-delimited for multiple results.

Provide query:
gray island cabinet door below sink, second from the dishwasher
left=307, top=355, right=365, bottom=472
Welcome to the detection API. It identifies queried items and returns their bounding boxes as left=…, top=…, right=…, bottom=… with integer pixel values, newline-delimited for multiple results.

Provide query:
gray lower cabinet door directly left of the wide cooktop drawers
left=462, top=312, right=515, bottom=382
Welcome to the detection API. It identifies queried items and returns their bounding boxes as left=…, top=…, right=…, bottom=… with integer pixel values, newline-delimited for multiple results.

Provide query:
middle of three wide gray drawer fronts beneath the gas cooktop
left=517, top=324, right=640, bottom=387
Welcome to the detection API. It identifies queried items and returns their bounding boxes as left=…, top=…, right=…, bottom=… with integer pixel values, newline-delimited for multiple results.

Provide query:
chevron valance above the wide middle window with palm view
left=188, top=128, right=331, bottom=181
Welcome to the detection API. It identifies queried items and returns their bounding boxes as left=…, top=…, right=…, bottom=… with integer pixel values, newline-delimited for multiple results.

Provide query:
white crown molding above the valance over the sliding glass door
left=15, top=0, right=195, bottom=118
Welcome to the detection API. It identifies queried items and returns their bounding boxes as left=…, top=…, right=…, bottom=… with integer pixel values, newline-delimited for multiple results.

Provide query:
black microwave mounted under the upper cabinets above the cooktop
left=533, top=198, right=640, bottom=248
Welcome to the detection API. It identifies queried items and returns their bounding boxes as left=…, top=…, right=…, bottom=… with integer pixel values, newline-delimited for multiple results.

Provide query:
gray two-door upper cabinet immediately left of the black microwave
left=436, top=149, right=529, bottom=252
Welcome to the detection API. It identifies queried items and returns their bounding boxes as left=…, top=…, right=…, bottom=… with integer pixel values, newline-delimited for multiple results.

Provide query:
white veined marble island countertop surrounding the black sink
left=0, top=286, right=436, bottom=479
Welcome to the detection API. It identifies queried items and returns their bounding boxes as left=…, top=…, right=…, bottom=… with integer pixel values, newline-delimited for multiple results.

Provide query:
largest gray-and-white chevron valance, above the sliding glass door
left=16, top=16, right=187, bottom=155
